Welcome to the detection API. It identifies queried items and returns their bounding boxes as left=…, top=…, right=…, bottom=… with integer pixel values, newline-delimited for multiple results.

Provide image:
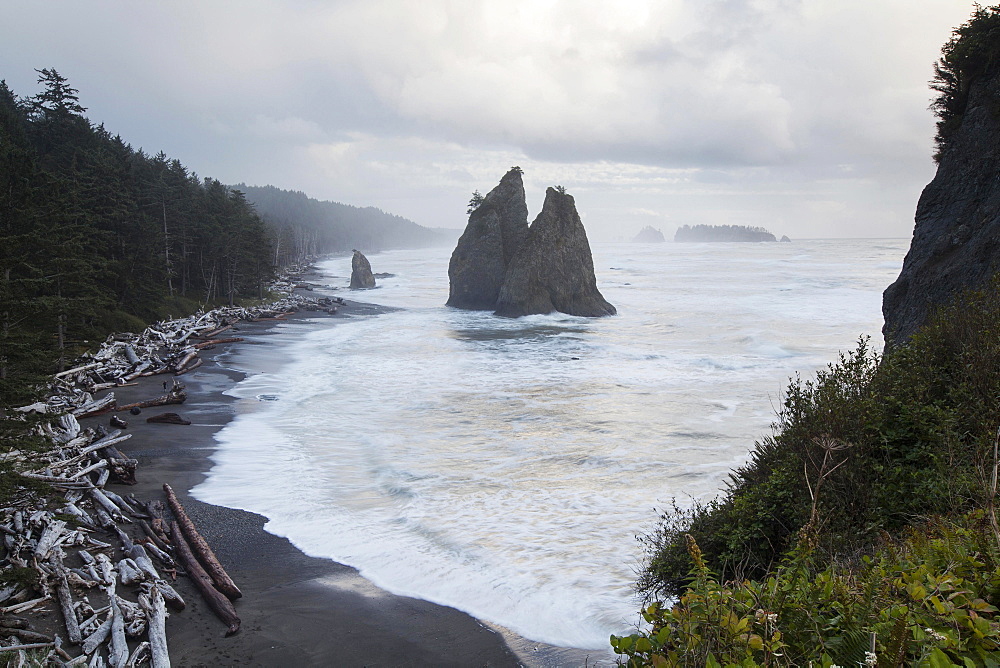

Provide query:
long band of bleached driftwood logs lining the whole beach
left=0, top=278, right=344, bottom=668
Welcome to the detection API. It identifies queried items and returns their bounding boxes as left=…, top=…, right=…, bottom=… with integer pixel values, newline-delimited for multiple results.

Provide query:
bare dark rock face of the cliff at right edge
left=882, top=75, right=1000, bottom=345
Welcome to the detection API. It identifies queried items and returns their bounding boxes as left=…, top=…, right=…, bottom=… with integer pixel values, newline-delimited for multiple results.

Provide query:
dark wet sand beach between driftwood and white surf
left=81, top=302, right=594, bottom=667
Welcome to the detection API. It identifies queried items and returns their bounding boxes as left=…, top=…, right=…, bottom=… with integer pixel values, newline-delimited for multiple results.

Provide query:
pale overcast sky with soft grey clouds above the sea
left=0, top=0, right=973, bottom=240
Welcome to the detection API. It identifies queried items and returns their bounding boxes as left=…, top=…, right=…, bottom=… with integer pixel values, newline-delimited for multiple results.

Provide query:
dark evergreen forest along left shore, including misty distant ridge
left=0, top=68, right=436, bottom=404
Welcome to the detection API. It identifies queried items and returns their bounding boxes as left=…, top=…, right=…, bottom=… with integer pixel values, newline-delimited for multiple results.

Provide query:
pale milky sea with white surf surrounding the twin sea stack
left=194, top=239, right=907, bottom=649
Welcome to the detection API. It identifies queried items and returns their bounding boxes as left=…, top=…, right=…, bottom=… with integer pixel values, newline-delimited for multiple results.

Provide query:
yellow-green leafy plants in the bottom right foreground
left=611, top=512, right=1000, bottom=667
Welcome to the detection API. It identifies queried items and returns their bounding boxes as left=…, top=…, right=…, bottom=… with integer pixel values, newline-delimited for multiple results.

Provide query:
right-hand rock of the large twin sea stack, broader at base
left=496, top=188, right=617, bottom=317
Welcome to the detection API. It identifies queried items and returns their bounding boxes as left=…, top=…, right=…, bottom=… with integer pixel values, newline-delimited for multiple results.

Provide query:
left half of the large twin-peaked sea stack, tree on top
left=448, top=167, right=528, bottom=311
